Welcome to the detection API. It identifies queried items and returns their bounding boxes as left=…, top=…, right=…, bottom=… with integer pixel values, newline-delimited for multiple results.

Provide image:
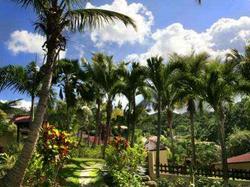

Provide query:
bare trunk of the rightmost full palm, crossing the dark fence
left=218, top=105, right=228, bottom=187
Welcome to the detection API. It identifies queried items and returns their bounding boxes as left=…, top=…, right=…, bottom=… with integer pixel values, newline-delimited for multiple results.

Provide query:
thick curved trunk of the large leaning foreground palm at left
left=0, top=54, right=55, bottom=187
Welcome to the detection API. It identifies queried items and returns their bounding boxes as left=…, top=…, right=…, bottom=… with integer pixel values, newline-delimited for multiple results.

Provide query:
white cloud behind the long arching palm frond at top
left=86, top=0, right=154, bottom=47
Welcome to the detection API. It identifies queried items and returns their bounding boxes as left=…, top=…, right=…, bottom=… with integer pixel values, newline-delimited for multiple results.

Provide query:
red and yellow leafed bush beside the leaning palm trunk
left=25, top=125, right=74, bottom=186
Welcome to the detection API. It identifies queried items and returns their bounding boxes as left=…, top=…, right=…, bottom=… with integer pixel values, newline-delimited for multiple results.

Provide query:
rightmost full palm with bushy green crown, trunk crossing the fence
left=202, top=60, right=237, bottom=187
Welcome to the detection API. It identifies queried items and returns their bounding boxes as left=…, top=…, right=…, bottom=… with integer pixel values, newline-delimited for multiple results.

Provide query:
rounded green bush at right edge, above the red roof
left=227, top=130, right=250, bottom=156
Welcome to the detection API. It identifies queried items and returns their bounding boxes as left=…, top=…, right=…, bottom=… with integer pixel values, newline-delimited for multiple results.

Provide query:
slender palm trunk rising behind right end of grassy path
left=102, top=96, right=112, bottom=158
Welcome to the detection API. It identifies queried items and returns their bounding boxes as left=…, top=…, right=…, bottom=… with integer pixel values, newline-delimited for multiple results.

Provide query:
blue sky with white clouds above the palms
left=0, top=0, right=250, bottom=109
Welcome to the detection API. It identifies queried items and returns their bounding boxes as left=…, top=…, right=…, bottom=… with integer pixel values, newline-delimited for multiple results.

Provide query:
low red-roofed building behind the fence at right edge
left=214, top=152, right=250, bottom=171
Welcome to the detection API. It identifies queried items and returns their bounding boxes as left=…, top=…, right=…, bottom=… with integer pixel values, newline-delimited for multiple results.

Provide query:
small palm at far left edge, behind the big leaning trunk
left=0, top=62, right=41, bottom=119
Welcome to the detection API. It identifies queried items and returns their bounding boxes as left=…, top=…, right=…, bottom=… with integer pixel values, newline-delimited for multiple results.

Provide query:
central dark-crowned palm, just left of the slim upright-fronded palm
left=119, top=62, right=149, bottom=147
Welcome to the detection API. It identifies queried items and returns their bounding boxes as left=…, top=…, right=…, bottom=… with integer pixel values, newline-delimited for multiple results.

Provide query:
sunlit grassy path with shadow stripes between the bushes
left=59, top=158, right=104, bottom=187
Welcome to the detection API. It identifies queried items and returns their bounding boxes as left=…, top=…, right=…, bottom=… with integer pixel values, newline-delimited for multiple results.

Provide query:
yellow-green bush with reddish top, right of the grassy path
left=106, top=137, right=146, bottom=187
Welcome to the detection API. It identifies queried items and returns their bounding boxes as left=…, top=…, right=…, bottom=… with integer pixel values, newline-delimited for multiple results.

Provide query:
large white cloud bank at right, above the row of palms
left=127, top=17, right=250, bottom=64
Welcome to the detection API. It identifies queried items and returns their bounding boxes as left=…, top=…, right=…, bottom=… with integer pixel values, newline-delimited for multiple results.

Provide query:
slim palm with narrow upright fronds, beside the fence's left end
left=147, top=57, right=164, bottom=178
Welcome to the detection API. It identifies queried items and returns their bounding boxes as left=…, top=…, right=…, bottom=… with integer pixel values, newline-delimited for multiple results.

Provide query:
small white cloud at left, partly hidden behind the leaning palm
left=7, top=30, right=66, bottom=59
